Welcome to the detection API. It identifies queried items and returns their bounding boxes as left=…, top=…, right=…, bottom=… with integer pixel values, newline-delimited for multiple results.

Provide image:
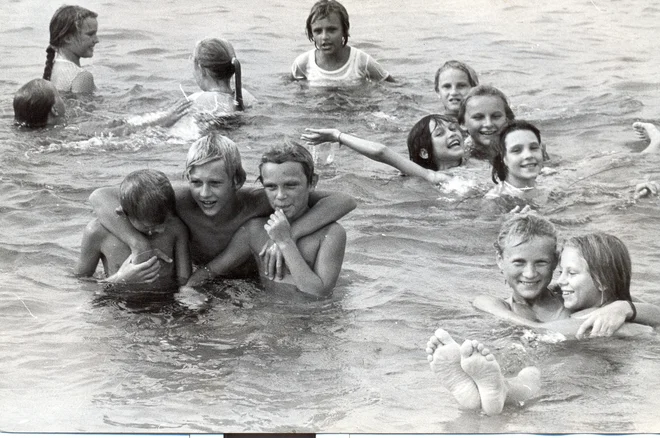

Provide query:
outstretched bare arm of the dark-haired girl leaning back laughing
left=301, top=128, right=449, bottom=184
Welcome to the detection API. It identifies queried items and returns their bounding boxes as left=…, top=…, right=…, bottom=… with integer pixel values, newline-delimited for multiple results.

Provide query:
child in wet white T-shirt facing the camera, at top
left=291, top=0, right=394, bottom=86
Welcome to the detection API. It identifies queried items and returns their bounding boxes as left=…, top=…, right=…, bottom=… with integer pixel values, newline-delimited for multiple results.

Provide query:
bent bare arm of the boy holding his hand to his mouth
left=264, top=210, right=346, bottom=297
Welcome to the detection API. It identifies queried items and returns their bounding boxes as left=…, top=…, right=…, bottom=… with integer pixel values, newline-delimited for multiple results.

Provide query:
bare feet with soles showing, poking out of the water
left=426, top=329, right=541, bottom=415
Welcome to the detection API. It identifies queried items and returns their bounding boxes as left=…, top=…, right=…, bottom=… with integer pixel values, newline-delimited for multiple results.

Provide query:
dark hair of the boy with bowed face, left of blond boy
left=119, top=169, right=176, bottom=224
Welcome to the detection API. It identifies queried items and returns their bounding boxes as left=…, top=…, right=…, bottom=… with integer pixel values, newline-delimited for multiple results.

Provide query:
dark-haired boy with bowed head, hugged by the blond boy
left=76, top=169, right=192, bottom=289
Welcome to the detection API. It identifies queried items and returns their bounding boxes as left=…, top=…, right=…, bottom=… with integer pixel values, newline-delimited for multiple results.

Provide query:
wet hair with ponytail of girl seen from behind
left=194, top=38, right=244, bottom=111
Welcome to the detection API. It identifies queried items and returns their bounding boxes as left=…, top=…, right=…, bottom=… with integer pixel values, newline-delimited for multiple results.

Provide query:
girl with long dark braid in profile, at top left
left=43, top=6, right=99, bottom=93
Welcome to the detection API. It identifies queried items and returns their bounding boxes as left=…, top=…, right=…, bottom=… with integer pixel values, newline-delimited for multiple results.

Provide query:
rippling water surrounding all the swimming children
left=0, top=0, right=660, bottom=433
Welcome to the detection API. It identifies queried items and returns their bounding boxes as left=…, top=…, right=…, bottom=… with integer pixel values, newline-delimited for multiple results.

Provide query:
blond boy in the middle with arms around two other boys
left=89, top=133, right=356, bottom=279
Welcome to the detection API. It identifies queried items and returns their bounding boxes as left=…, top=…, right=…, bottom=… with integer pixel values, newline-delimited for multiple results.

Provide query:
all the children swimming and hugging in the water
left=14, top=0, right=660, bottom=415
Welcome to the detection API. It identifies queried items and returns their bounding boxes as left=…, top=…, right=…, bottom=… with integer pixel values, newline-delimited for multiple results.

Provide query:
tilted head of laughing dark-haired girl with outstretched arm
left=407, top=114, right=464, bottom=170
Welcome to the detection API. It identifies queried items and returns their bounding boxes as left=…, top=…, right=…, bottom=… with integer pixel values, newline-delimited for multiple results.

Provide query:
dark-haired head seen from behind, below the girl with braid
left=14, top=79, right=57, bottom=128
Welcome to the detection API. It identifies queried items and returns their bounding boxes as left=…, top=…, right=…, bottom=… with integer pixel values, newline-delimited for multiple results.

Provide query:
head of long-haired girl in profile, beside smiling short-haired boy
left=558, top=233, right=632, bottom=310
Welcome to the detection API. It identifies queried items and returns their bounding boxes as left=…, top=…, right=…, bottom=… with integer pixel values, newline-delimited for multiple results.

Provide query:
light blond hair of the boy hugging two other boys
left=184, top=132, right=246, bottom=188
